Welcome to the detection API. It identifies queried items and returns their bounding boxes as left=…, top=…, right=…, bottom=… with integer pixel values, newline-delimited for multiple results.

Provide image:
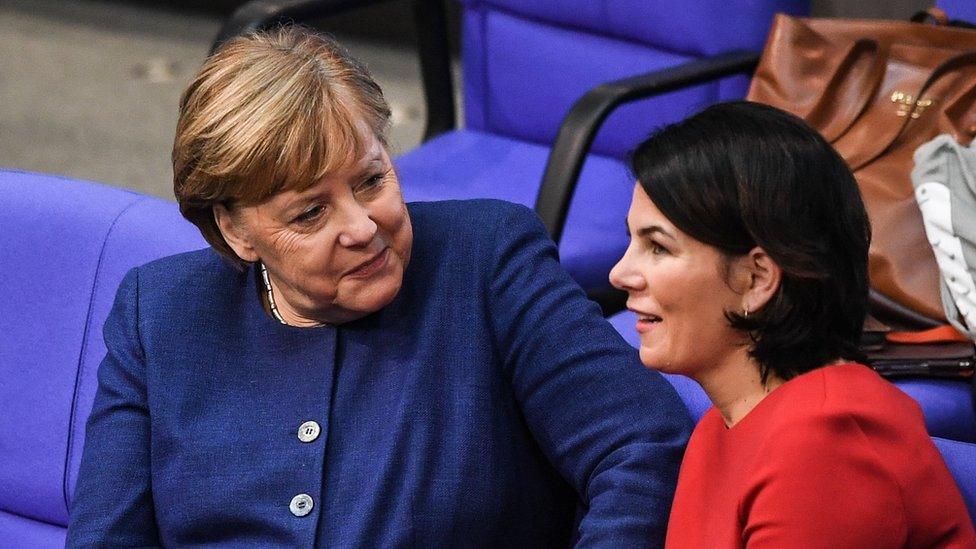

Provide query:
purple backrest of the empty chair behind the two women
left=461, top=0, right=809, bottom=158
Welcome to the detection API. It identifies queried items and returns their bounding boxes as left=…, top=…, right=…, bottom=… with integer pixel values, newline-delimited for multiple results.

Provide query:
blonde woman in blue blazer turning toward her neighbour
left=68, top=28, right=690, bottom=547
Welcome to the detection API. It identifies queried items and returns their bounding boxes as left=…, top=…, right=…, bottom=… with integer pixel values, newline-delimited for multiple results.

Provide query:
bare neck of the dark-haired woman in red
left=697, top=349, right=783, bottom=429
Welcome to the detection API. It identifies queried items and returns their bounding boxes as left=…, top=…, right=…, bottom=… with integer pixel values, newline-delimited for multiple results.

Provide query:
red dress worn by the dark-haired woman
left=667, top=364, right=976, bottom=549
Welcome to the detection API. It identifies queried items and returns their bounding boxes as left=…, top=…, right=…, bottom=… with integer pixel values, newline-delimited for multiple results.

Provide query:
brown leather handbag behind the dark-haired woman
left=748, top=9, right=976, bottom=322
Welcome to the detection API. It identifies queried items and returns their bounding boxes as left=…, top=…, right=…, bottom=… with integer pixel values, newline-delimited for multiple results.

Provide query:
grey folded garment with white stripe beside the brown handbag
left=912, top=134, right=976, bottom=340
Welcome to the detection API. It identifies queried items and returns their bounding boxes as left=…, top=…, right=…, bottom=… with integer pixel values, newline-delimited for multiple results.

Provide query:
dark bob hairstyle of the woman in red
left=631, top=101, right=871, bottom=381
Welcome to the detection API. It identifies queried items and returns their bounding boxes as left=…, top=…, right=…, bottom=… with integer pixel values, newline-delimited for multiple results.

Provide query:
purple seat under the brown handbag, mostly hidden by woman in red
left=609, top=311, right=976, bottom=440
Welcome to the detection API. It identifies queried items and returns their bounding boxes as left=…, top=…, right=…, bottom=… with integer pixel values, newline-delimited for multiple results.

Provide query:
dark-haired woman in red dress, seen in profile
left=610, top=102, right=976, bottom=547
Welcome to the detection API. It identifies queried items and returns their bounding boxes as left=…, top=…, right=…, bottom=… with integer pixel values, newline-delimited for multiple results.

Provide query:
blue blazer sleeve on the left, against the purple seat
left=66, top=270, right=159, bottom=547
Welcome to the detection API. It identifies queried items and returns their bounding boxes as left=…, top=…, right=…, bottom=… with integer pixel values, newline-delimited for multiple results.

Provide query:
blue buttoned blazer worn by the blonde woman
left=67, top=201, right=691, bottom=547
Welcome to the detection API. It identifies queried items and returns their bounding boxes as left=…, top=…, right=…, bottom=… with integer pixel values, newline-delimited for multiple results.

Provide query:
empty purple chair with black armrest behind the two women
left=397, top=0, right=808, bottom=291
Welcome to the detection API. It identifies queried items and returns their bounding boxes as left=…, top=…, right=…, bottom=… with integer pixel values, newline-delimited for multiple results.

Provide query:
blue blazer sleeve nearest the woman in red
left=486, top=207, right=691, bottom=547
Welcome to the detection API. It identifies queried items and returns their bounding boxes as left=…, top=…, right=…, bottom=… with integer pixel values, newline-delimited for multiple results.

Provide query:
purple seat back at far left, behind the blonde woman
left=0, top=170, right=206, bottom=547
